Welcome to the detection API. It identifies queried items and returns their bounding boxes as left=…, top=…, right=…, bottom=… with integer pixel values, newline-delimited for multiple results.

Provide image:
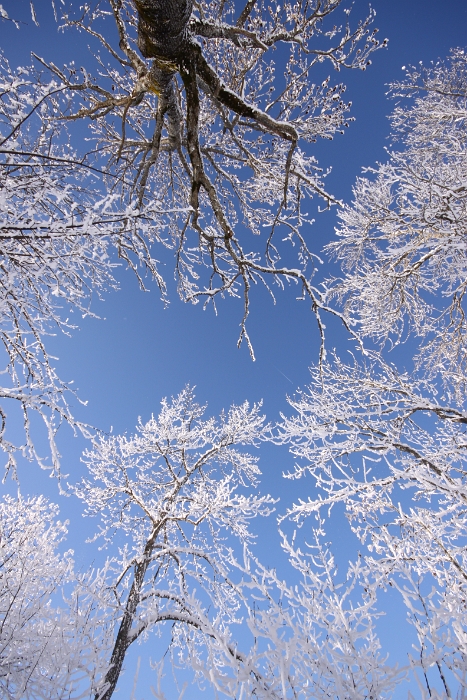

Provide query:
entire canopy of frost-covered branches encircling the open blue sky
left=0, top=0, right=467, bottom=700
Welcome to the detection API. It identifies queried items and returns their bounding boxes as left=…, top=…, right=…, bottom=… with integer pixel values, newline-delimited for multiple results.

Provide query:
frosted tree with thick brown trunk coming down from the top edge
left=33, top=0, right=386, bottom=352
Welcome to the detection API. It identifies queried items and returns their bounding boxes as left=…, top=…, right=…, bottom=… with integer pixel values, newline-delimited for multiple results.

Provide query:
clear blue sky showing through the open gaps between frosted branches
left=0, top=0, right=467, bottom=700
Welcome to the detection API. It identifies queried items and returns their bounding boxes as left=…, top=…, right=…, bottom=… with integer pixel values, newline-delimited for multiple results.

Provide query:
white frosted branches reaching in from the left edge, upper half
left=0, top=58, right=167, bottom=473
